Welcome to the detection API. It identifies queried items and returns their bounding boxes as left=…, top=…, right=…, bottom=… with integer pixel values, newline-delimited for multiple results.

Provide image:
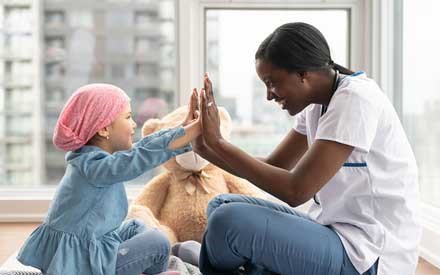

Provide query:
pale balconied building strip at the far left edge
left=0, top=0, right=42, bottom=186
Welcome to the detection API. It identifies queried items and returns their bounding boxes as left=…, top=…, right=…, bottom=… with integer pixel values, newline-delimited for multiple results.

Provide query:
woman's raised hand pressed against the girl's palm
left=200, top=73, right=223, bottom=149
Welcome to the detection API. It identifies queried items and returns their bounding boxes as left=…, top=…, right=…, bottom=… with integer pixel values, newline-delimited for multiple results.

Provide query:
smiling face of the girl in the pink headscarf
left=107, top=104, right=137, bottom=152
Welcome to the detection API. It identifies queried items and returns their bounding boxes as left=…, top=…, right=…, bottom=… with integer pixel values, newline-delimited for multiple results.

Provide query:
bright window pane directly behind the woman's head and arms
left=205, top=9, right=350, bottom=155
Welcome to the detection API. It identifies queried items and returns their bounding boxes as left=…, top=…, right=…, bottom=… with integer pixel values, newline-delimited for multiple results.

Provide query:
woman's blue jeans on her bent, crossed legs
left=200, top=194, right=378, bottom=275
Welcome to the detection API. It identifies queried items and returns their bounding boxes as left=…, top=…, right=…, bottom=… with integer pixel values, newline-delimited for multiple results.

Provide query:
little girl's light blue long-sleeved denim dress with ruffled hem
left=17, top=127, right=191, bottom=275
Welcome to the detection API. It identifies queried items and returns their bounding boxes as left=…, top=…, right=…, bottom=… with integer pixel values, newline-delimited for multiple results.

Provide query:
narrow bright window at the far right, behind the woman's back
left=402, top=0, right=440, bottom=207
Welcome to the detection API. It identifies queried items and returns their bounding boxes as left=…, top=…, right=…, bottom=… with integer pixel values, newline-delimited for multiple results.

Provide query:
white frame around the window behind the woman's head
left=178, top=0, right=371, bottom=108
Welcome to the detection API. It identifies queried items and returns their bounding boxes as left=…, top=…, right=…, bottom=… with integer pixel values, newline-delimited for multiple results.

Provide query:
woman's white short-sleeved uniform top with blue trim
left=294, top=72, right=421, bottom=275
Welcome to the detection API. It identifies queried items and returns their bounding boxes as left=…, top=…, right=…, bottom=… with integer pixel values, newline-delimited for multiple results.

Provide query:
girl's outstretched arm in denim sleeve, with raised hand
left=80, top=90, right=200, bottom=186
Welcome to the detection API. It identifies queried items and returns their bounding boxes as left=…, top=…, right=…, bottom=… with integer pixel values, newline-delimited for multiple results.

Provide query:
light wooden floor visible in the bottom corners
left=0, top=223, right=440, bottom=275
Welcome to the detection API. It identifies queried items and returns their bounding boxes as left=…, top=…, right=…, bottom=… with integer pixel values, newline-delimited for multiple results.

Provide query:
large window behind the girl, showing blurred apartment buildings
left=0, top=0, right=177, bottom=188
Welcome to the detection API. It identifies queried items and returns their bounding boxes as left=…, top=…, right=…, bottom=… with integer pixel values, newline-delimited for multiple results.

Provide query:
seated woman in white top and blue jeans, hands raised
left=195, top=23, right=421, bottom=275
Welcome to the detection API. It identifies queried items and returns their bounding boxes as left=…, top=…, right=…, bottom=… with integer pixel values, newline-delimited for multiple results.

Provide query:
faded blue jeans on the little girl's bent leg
left=116, top=220, right=170, bottom=275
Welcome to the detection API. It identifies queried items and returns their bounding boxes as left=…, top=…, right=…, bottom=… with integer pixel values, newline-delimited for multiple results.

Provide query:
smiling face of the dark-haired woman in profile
left=255, top=59, right=311, bottom=116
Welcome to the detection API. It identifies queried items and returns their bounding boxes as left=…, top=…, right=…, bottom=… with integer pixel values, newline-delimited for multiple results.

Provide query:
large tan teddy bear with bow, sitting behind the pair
left=127, top=106, right=271, bottom=244
